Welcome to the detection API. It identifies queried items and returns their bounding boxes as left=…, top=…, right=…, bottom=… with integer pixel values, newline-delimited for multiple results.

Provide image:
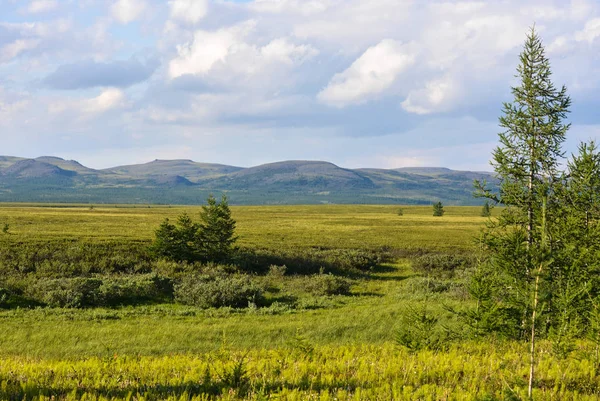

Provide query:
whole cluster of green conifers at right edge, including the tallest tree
left=470, top=29, right=600, bottom=396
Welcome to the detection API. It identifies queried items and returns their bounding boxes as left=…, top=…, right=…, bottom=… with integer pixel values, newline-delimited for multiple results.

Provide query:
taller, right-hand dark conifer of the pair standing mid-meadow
left=196, top=195, right=237, bottom=262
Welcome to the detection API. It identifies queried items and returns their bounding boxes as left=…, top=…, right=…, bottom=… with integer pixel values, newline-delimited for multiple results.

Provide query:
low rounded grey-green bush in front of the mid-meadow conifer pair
left=175, top=274, right=263, bottom=308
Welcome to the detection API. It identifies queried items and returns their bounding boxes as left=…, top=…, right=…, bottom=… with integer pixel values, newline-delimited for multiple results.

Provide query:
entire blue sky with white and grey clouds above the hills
left=0, top=0, right=600, bottom=171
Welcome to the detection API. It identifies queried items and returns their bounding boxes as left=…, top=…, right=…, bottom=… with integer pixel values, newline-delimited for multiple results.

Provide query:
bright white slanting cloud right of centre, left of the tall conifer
left=318, top=39, right=415, bottom=107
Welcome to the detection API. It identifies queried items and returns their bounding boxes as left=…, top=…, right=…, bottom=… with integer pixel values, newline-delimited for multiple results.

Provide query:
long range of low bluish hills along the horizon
left=0, top=156, right=494, bottom=205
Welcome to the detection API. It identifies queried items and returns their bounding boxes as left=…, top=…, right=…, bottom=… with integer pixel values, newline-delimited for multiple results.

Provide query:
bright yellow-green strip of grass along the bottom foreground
left=0, top=342, right=600, bottom=401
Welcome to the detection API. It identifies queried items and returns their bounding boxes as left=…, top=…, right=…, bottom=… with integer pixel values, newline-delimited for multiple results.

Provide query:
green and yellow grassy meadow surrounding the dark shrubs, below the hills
left=0, top=204, right=600, bottom=400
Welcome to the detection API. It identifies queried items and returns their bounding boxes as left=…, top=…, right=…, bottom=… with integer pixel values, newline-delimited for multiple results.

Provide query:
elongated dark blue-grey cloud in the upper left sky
left=44, top=58, right=158, bottom=90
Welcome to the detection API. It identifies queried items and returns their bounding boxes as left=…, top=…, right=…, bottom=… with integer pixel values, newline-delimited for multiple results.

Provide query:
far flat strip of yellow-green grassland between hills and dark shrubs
left=0, top=205, right=487, bottom=250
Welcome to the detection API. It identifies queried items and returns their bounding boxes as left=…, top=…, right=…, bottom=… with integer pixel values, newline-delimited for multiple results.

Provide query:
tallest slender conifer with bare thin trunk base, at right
left=476, top=28, right=571, bottom=396
